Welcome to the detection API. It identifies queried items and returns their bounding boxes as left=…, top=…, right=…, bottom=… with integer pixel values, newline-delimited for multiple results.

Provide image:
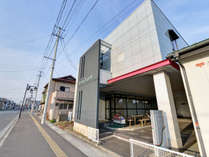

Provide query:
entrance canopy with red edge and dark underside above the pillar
left=101, top=59, right=184, bottom=97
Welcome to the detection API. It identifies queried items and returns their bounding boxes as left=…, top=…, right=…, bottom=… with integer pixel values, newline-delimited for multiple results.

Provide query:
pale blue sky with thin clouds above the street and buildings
left=0, top=0, right=209, bottom=101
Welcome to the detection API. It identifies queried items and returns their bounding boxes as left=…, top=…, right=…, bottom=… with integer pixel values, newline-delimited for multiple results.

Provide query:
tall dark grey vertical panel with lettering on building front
left=75, top=40, right=101, bottom=128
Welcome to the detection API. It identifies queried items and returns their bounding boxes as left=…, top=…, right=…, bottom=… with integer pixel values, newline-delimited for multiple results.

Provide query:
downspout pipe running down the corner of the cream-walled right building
left=178, top=61, right=207, bottom=157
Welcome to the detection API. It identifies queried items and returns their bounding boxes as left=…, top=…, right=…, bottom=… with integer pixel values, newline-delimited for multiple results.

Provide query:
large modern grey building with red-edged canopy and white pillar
left=74, top=0, right=200, bottom=155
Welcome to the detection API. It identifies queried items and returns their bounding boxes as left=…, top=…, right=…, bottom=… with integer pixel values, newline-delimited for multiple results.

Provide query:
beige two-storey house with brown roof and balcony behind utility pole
left=41, top=75, right=76, bottom=120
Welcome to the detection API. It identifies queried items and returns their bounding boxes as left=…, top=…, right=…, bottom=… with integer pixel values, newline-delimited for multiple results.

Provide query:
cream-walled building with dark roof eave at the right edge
left=168, top=39, right=209, bottom=156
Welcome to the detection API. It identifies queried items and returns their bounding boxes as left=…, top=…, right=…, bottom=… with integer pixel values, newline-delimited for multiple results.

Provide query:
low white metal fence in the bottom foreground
left=129, top=139, right=193, bottom=157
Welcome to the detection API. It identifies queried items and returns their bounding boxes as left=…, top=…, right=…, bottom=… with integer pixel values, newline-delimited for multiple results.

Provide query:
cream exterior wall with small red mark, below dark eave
left=183, top=52, right=209, bottom=156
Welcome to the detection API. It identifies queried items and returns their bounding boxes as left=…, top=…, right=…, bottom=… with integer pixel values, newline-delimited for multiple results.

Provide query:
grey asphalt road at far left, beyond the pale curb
left=0, top=111, right=18, bottom=132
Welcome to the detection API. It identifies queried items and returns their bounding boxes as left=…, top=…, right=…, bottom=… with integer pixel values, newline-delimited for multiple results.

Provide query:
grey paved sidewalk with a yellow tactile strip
left=0, top=113, right=85, bottom=157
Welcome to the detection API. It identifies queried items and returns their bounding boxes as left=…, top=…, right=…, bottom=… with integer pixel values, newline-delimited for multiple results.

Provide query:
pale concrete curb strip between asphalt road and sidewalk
left=0, top=115, right=19, bottom=147
